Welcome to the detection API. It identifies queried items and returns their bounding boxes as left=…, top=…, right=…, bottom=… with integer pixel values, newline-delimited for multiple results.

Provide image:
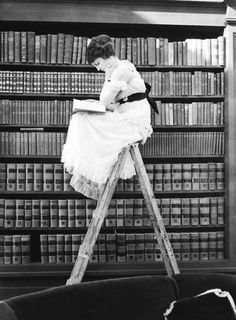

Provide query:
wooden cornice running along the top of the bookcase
left=0, top=0, right=226, bottom=27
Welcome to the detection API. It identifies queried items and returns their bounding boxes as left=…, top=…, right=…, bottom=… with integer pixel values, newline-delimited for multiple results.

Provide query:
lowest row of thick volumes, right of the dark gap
left=40, top=231, right=225, bottom=263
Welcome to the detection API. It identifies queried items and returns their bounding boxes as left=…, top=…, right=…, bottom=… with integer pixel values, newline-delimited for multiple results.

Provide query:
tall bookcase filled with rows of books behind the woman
left=0, top=2, right=235, bottom=297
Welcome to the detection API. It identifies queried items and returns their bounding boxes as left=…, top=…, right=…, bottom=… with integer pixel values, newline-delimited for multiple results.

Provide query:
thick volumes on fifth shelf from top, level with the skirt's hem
left=0, top=162, right=224, bottom=192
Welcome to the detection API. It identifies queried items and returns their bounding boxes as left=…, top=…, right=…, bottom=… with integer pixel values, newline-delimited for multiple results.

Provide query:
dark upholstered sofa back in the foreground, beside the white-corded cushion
left=0, top=274, right=236, bottom=320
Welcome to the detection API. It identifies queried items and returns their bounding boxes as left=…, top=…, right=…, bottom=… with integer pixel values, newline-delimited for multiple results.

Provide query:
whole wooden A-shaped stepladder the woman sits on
left=66, top=144, right=179, bottom=284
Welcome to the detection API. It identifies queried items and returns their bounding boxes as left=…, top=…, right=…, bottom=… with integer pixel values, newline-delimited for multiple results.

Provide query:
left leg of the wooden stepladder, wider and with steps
left=66, top=146, right=130, bottom=284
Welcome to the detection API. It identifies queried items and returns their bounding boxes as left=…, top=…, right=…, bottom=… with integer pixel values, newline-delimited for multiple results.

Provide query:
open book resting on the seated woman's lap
left=73, top=99, right=106, bottom=113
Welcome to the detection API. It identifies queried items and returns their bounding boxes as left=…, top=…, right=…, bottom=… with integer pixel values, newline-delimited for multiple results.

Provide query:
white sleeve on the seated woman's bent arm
left=100, top=66, right=132, bottom=106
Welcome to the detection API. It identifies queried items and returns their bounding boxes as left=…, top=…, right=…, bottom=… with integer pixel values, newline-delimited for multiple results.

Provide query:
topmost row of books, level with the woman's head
left=0, top=30, right=225, bottom=65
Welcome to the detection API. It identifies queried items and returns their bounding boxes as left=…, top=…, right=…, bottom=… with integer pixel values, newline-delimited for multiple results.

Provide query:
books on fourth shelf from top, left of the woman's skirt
left=0, top=131, right=66, bottom=156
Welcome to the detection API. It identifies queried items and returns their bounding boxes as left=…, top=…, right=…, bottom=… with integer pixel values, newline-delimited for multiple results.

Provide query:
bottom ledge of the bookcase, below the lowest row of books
left=0, top=259, right=235, bottom=279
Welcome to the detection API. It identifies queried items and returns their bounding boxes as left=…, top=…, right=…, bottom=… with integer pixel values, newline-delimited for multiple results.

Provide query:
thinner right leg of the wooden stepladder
left=130, top=145, right=179, bottom=275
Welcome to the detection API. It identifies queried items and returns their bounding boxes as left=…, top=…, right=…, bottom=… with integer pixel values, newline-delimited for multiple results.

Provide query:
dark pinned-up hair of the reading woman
left=86, top=34, right=115, bottom=64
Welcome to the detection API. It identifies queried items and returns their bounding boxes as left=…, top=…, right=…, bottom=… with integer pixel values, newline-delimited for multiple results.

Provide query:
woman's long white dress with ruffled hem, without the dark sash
left=61, top=59, right=152, bottom=199
